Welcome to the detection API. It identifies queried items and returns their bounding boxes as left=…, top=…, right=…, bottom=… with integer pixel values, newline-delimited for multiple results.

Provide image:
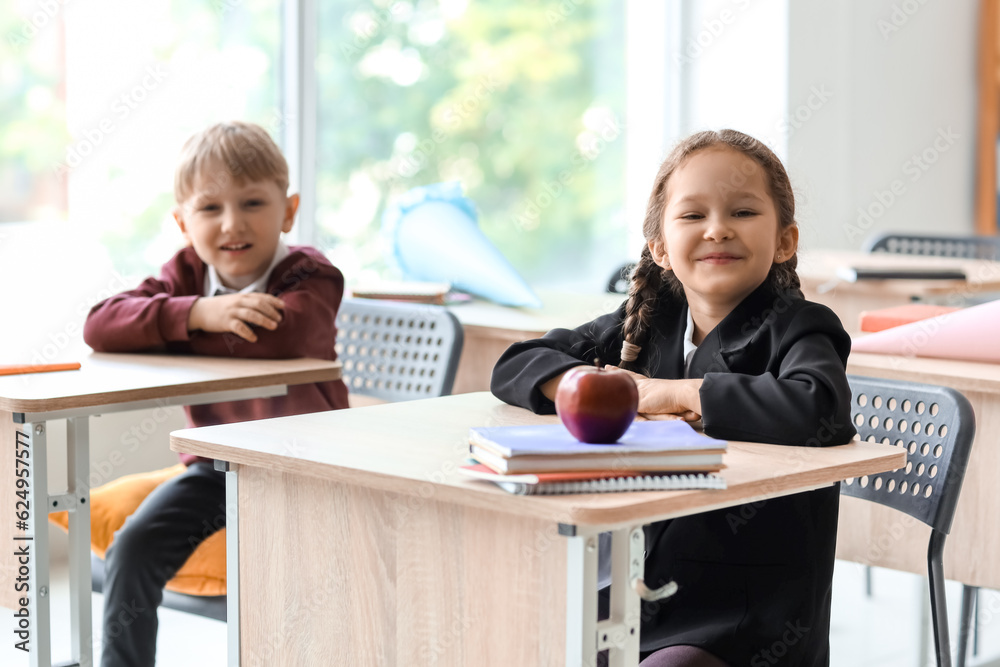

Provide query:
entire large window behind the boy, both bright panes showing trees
left=0, top=0, right=634, bottom=289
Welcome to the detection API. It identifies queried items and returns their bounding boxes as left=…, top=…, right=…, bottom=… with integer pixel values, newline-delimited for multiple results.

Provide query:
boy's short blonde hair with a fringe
left=174, top=121, right=288, bottom=204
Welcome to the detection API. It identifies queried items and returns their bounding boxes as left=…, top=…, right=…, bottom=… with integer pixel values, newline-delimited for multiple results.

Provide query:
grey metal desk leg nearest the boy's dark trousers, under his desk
left=66, top=417, right=94, bottom=667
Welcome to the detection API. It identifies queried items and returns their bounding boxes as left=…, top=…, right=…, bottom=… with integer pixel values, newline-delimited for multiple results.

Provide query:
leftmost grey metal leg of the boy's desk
left=21, top=422, right=52, bottom=667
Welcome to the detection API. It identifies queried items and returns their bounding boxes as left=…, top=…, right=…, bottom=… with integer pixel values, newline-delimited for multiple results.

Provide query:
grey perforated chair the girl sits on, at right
left=840, top=375, right=976, bottom=667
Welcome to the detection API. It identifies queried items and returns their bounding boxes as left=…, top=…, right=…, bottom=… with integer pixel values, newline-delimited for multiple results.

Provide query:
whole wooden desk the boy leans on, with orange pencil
left=0, top=354, right=340, bottom=667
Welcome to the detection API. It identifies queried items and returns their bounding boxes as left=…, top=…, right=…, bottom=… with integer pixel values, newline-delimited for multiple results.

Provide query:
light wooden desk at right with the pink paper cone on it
left=837, top=353, right=1000, bottom=589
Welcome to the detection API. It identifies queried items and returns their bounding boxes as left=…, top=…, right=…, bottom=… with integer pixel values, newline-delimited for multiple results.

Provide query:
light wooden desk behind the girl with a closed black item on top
left=798, top=250, right=1000, bottom=334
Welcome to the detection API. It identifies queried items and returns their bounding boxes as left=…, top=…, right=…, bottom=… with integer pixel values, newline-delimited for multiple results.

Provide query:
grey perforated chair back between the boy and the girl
left=335, top=299, right=464, bottom=401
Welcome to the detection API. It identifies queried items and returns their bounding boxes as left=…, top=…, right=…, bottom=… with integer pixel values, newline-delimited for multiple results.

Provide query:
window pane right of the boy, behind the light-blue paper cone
left=316, top=0, right=627, bottom=289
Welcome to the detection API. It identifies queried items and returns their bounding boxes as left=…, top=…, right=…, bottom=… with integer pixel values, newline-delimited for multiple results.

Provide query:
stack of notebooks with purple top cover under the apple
left=463, top=420, right=726, bottom=494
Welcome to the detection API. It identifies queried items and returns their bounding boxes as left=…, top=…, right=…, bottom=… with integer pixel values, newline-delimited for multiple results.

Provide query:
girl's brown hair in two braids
left=621, top=130, right=802, bottom=369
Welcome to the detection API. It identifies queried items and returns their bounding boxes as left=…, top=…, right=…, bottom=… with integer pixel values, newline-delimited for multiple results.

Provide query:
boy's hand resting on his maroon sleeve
left=188, top=292, right=285, bottom=343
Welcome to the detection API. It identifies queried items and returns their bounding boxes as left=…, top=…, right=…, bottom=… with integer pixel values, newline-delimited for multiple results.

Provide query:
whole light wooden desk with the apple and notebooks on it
left=170, top=393, right=905, bottom=667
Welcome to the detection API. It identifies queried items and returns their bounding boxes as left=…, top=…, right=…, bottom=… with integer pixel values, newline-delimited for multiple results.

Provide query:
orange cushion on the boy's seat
left=49, top=463, right=226, bottom=595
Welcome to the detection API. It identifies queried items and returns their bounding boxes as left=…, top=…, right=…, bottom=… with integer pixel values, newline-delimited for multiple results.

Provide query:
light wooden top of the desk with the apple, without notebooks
left=170, top=393, right=905, bottom=525
